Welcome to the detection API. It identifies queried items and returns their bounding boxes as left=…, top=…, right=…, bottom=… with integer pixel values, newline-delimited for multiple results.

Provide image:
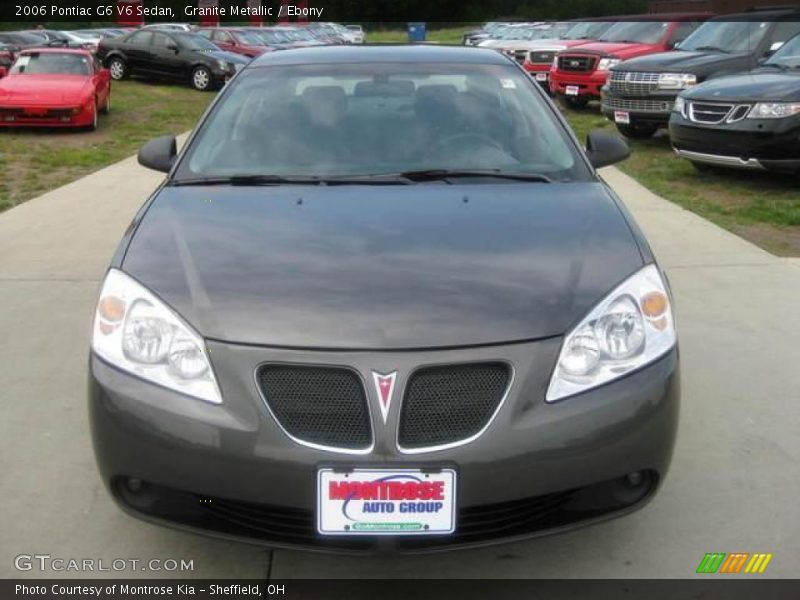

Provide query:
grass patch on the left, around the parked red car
left=0, top=81, right=213, bottom=211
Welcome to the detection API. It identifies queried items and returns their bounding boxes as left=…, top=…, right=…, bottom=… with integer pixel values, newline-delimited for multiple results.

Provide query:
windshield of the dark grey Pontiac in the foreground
left=176, top=63, right=587, bottom=180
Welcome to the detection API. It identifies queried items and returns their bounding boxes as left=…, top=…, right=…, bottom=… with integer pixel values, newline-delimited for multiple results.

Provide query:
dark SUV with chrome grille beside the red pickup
left=602, top=9, right=800, bottom=138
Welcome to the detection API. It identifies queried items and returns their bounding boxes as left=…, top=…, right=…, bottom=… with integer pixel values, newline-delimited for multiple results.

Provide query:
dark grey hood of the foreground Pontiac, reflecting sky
left=122, top=183, right=643, bottom=349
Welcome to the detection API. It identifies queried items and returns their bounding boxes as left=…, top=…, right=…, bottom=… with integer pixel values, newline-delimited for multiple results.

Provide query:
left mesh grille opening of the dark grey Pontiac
left=256, top=365, right=372, bottom=450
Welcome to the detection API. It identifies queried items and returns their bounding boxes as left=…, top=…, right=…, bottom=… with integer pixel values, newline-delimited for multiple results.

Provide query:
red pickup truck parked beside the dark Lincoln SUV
left=550, top=13, right=713, bottom=108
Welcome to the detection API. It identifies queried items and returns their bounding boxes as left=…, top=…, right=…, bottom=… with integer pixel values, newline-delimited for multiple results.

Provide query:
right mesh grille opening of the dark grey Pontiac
left=397, top=363, right=510, bottom=449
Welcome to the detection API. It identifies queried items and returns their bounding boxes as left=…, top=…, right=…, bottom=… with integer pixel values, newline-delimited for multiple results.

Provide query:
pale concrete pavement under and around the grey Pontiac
left=0, top=159, right=800, bottom=578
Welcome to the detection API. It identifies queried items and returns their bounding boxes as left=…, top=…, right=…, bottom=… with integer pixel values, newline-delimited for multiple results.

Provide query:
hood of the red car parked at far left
left=0, top=75, right=92, bottom=106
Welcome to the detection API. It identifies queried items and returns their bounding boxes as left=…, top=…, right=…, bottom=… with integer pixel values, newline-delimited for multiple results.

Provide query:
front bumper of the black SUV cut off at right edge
left=669, top=113, right=800, bottom=173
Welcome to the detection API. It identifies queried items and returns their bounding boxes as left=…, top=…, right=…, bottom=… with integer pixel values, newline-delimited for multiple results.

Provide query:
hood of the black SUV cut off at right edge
left=685, top=68, right=800, bottom=102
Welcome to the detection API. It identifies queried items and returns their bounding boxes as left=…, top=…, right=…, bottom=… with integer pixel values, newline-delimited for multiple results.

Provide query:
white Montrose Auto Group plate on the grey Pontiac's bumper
left=317, top=468, right=456, bottom=535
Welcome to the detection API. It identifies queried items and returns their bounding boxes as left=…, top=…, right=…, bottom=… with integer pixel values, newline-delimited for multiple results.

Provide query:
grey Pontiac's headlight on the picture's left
left=92, top=269, right=222, bottom=404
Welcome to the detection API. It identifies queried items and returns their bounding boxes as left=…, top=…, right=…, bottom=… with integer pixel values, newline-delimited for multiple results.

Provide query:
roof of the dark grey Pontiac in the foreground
left=250, top=44, right=511, bottom=67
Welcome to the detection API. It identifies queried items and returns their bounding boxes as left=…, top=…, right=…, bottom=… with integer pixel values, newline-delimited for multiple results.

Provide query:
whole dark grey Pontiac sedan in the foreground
left=89, top=46, right=679, bottom=552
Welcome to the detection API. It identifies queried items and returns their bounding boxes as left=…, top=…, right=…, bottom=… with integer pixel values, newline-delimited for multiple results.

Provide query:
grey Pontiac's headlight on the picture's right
left=546, top=265, right=676, bottom=402
